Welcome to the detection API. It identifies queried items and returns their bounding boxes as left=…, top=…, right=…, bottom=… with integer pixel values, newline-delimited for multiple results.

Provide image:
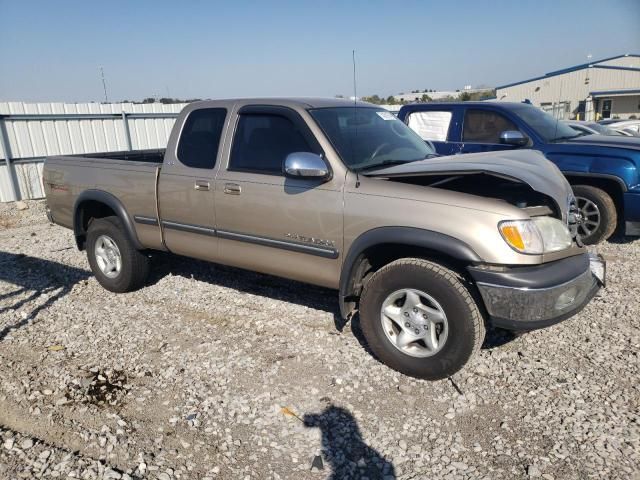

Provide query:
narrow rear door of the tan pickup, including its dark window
left=158, top=108, right=228, bottom=260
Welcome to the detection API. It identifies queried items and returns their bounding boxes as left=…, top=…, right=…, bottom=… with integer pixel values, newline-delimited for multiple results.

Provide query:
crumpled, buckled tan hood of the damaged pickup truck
left=362, top=150, right=573, bottom=218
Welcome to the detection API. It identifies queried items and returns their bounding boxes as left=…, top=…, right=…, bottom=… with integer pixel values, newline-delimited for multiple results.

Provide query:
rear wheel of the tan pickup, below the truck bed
left=87, top=217, right=149, bottom=293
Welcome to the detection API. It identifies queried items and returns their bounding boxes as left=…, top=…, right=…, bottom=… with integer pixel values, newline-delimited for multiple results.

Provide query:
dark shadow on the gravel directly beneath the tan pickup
left=149, top=253, right=516, bottom=356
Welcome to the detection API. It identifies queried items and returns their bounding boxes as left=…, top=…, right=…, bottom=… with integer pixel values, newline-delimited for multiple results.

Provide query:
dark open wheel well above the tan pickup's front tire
left=345, top=243, right=468, bottom=305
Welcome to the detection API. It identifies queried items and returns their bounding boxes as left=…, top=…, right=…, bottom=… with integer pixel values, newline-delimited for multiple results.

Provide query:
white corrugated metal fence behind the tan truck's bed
left=0, top=102, right=185, bottom=202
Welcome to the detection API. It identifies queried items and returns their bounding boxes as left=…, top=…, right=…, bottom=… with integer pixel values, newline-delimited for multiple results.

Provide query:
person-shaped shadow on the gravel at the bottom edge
left=303, top=405, right=396, bottom=480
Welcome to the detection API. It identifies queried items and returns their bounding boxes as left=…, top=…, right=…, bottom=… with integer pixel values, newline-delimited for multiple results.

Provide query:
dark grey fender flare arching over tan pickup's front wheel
left=339, top=227, right=482, bottom=319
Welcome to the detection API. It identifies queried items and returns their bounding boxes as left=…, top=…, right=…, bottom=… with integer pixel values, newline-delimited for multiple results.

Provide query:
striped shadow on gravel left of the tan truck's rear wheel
left=0, top=251, right=90, bottom=341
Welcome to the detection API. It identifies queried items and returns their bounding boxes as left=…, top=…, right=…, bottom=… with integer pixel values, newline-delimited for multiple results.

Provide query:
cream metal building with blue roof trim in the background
left=496, top=54, right=640, bottom=120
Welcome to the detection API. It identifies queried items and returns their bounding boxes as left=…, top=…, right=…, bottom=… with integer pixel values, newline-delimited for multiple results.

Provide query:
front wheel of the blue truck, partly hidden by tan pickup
left=572, top=185, right=618, bottom=245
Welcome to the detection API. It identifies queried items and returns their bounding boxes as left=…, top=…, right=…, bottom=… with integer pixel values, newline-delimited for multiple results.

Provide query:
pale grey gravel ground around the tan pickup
left=0, top=202, right=640, bottom=480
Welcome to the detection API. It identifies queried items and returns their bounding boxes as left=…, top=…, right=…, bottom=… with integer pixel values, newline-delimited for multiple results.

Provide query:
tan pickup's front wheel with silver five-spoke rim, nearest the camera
left=360, top=258, right=485, bottom=380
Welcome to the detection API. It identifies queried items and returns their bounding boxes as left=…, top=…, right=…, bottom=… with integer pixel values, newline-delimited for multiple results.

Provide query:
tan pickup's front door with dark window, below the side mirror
left=215, top=105, right=344, bottom=286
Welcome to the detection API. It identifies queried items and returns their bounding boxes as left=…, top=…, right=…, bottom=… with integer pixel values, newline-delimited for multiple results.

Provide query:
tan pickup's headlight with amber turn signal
left=498, top=217, right=571, bottom=254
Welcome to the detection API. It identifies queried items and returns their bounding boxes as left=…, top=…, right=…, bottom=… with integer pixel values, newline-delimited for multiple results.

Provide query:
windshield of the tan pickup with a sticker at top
left=310, top=107, right=436, bottom=171
